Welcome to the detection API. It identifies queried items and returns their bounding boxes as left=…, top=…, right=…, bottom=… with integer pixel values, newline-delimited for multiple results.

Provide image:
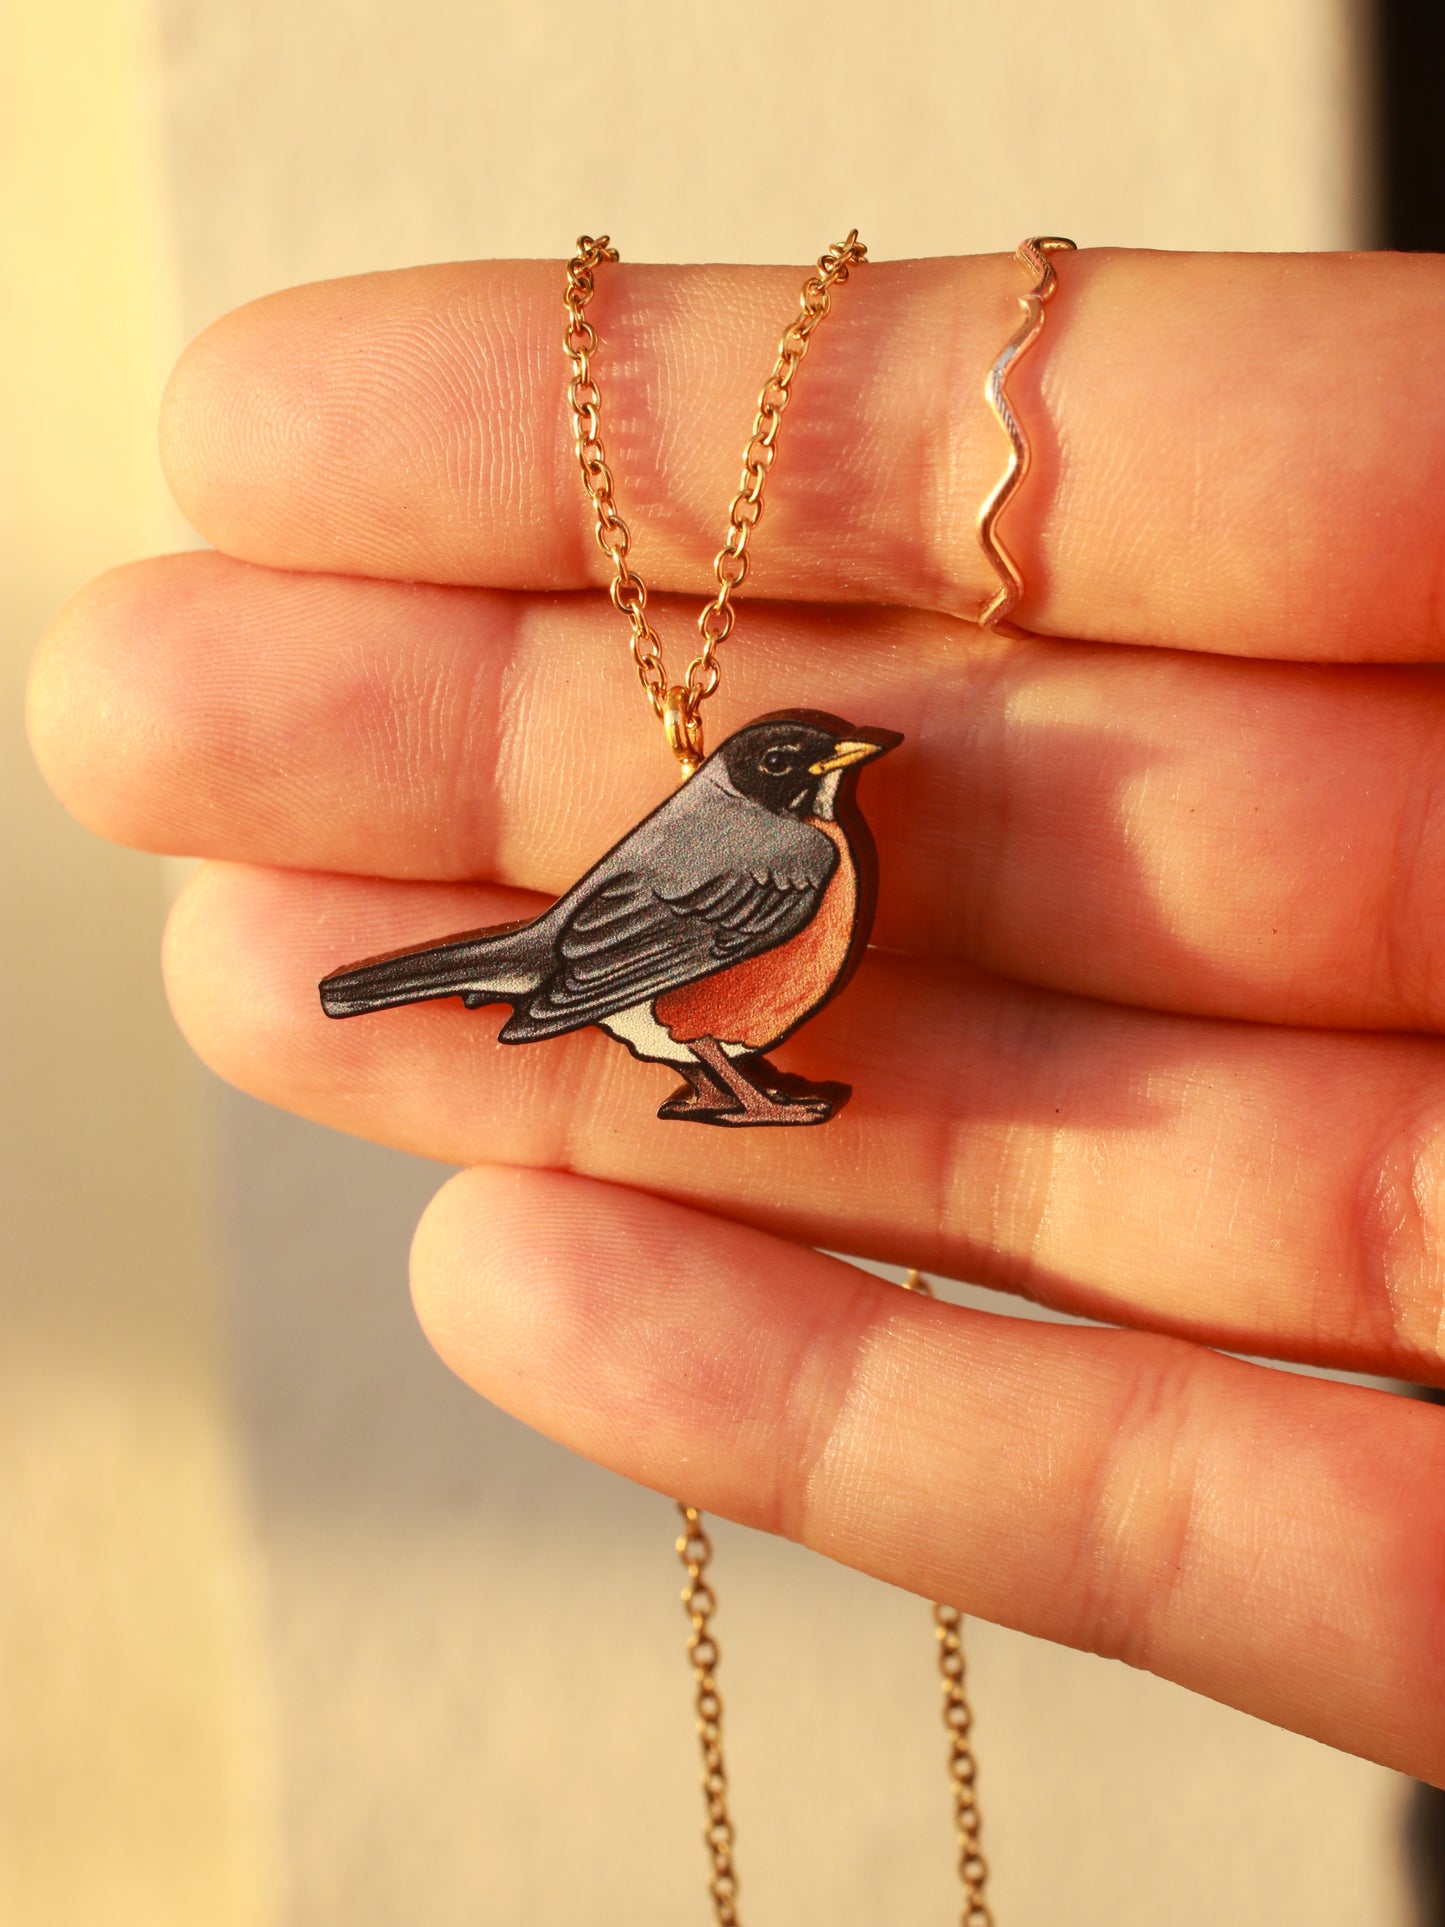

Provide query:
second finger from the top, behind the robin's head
left=31, top=555, right=1445, bottom=1029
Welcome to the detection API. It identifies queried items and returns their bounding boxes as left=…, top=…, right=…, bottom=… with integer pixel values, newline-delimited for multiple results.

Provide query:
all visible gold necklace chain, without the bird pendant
left=563, top=229, right=992, bottom=1927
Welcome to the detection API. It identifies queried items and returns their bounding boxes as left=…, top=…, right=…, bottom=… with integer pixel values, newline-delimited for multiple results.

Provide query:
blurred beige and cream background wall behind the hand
left=0, top=0, right=1414, bottom=1927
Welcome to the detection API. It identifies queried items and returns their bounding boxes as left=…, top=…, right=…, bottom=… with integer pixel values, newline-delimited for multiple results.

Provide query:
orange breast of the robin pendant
left=653, top=819, right=857, bottom=1050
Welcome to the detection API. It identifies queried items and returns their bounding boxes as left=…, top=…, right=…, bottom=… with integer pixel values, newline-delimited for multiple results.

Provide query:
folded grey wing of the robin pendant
left=501, top=779, right=838, bottom=1044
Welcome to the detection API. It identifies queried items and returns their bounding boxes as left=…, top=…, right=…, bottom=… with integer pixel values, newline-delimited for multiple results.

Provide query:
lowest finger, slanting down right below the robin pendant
left=412, top=1170, right=1445, bottom=1781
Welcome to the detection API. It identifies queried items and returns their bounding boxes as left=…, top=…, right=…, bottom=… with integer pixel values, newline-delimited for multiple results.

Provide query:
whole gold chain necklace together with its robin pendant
left=320, top=231, right=992, bottom=1927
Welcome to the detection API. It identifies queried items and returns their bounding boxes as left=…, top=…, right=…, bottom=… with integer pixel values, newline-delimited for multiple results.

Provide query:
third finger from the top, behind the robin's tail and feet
left=168, top=867, right=1445, bottom=1382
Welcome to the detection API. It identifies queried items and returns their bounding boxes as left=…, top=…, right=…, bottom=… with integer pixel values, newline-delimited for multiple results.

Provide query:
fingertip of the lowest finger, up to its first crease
left=402, top=1168, right=886, bottom=1530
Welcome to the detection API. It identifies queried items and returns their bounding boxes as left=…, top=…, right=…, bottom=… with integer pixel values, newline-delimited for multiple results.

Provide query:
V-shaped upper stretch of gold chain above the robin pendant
left=563, top=227, right=867, bottom=771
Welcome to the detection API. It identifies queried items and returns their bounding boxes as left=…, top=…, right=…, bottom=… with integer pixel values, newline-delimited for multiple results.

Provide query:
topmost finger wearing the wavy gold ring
left=162, top=251, right=1445, bottom=659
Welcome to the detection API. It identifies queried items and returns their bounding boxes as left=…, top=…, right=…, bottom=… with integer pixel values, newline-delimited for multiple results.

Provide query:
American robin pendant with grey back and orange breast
left=320, top=709, right=902, bottom=1129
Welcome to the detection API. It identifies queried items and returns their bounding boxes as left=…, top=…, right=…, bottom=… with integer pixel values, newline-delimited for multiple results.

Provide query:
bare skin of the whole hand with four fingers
left=31, top=252, right=1445, bottom=1784
